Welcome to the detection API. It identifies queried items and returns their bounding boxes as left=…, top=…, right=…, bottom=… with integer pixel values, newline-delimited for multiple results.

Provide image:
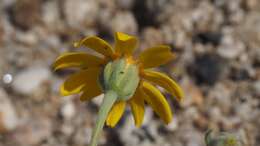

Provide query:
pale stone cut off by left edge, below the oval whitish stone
left=0, top=89, right=18, bottom=132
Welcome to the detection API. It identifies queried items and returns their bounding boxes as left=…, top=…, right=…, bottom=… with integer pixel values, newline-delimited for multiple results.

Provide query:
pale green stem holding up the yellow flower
left=90, top=90, right=118, bottom=146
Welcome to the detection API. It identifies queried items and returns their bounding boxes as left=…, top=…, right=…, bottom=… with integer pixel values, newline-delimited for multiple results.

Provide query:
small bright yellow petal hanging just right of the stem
left=106, top=101, right=126, bottom=127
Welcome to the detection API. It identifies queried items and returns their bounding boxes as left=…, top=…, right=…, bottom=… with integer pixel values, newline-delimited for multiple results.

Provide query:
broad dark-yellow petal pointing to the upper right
left=139, top=46, right=174, bottom=68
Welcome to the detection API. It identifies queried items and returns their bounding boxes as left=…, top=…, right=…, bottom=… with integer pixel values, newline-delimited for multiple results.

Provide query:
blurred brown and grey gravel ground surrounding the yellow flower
left=0, top=0, right=260, bottom=146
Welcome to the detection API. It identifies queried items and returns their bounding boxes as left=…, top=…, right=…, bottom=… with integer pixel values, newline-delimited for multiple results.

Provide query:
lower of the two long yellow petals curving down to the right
left=142, top=81, right=172, bottom=124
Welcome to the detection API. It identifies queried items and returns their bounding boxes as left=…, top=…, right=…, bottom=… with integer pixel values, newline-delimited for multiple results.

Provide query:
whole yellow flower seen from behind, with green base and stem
left=53, top=32, right=183, bottom=146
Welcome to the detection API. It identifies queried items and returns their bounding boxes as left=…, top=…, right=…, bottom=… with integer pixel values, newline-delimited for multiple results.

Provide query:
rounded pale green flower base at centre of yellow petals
left=101, top=59, right=140, bottom=100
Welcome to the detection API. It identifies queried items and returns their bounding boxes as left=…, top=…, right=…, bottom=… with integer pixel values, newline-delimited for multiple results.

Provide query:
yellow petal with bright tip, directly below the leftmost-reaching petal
left=60, top=68, right=100, bottom=96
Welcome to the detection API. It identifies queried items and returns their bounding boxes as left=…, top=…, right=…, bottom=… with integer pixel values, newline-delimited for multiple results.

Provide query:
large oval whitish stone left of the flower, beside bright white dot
left=12, top=66, right=51, bottom=95
